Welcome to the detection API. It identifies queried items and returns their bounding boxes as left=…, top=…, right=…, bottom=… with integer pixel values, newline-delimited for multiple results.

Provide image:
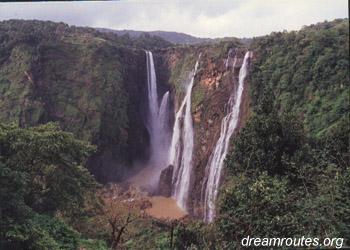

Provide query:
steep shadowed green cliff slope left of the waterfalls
left=0, top=21, right=164, bottom=181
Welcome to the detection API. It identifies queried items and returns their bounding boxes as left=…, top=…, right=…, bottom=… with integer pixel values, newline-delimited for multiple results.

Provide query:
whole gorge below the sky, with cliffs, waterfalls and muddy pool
left=0, top=19, right=350, bottom=249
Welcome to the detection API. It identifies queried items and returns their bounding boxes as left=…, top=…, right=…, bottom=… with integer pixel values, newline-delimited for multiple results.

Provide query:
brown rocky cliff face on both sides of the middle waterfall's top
left=155, top=44, right=249, bottom=216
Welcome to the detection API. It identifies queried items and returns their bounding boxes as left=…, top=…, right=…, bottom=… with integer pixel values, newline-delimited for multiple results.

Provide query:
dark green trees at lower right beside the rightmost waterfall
left=217, top=105, right=350, bottom=248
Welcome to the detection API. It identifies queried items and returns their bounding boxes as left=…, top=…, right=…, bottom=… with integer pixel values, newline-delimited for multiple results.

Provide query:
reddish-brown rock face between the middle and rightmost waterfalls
left=190, top=49, right=249, bottom=217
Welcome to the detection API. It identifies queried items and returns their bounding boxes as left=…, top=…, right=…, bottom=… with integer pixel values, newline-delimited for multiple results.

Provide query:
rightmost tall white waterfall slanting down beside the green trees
left=204, top=51, right=251, bottom=222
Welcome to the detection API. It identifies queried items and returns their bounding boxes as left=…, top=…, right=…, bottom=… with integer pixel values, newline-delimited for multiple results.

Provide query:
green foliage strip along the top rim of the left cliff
left=0, top=20, right=172, bottom=53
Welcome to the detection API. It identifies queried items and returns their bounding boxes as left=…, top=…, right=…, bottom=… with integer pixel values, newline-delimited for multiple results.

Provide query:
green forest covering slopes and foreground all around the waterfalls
left=0, top=19, right=350, bottom=250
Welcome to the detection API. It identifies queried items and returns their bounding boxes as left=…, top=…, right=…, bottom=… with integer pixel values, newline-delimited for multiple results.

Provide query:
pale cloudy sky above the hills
left=0, top=0, right=348, bottom=38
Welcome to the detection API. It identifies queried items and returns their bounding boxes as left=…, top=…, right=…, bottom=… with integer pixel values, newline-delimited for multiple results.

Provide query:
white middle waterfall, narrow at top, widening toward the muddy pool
left=169, top=55, right=200, bottom=211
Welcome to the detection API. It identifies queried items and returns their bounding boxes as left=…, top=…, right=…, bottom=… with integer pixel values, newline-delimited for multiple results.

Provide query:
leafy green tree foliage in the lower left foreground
left=0, top=123, right=104, bottom=249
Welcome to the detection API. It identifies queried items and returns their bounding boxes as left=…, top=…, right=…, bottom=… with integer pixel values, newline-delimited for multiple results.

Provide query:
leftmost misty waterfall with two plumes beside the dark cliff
left=146, top=51, right=170, bottom=177
